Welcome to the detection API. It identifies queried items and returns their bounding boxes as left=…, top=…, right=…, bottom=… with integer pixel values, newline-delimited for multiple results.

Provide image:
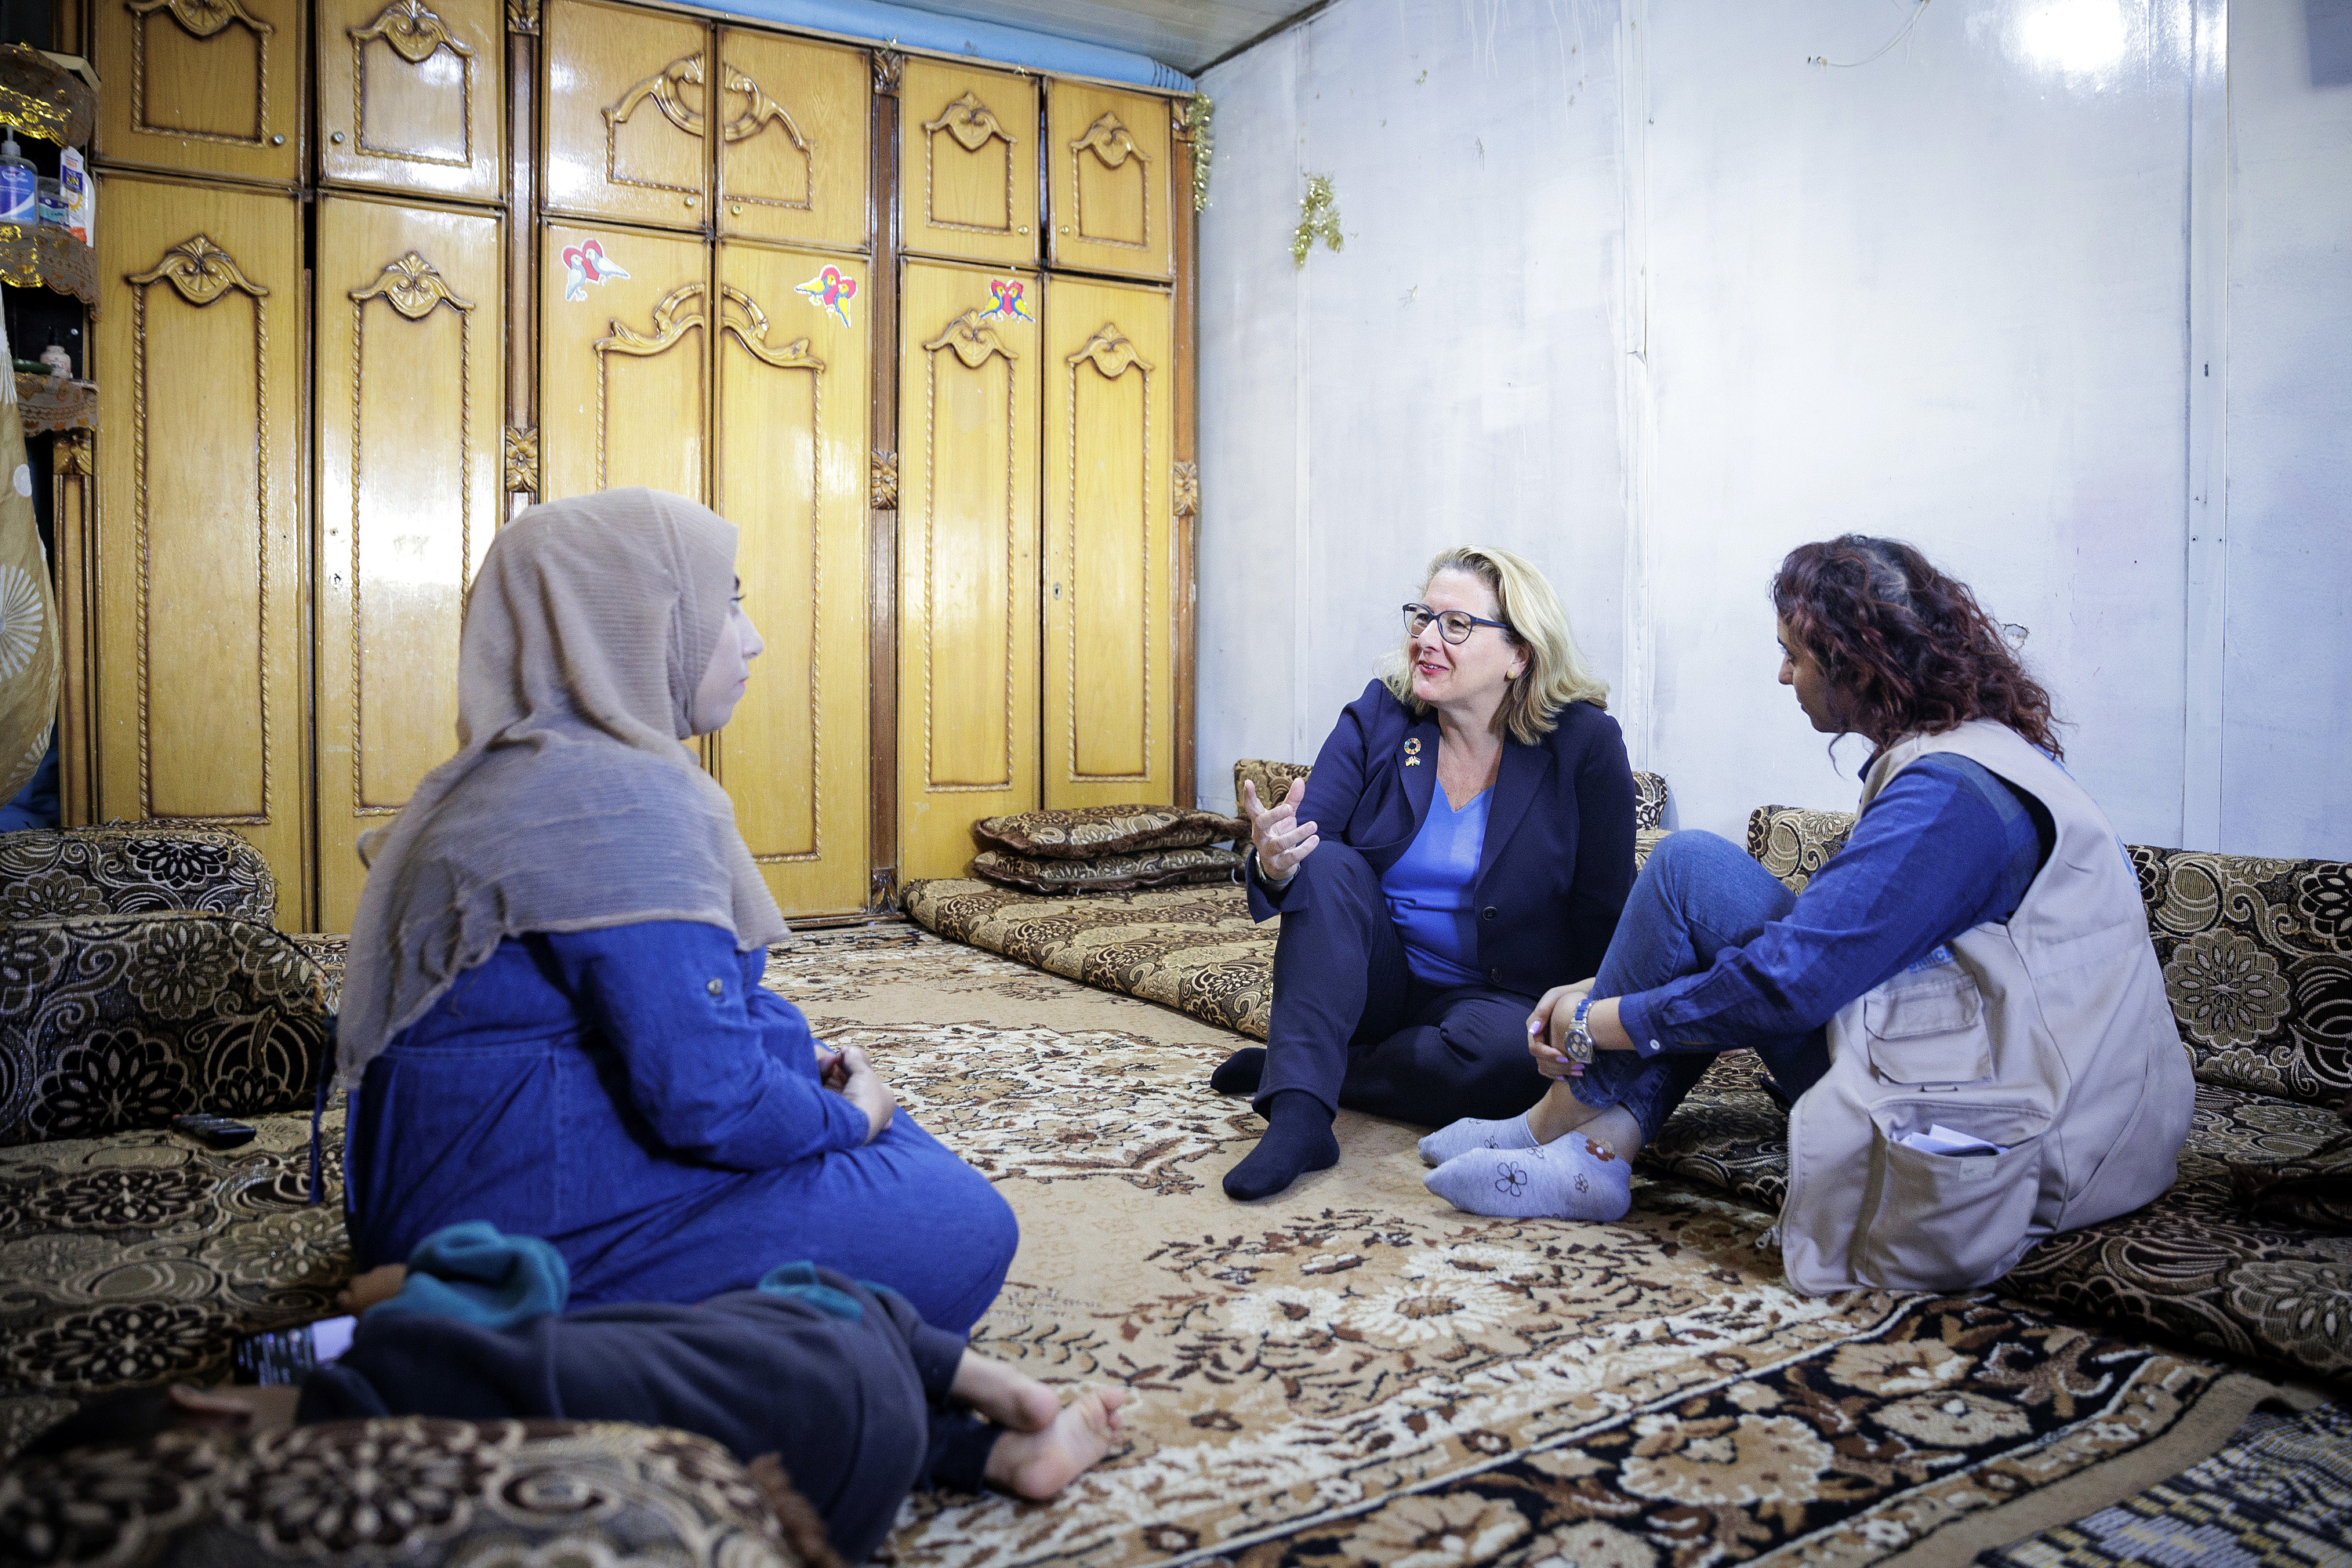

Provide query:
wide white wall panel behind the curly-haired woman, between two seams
left=1646, top=0, right=2187, bottom=844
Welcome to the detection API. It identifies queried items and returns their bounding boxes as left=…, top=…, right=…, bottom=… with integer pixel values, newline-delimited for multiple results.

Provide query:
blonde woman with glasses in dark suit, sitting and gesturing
left=1209, top=546, right=1632, bottom=1201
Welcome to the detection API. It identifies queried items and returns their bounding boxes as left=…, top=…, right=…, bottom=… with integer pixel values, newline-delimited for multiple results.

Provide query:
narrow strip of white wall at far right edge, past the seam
left=2220, top=0, right=2352, bottom=858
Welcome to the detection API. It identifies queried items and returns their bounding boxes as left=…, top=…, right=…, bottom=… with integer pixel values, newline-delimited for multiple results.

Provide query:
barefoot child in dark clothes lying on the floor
left=26, top=1222, right=1129, bottom=1561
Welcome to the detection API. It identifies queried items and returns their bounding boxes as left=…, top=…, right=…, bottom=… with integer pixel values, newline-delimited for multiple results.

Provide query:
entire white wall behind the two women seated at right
left=1200, top=0, right=2352, bottom=855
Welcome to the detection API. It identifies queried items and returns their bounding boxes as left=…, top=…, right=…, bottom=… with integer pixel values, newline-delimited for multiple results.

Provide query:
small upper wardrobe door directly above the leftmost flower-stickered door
left=543, top=0, right=710, bottom=228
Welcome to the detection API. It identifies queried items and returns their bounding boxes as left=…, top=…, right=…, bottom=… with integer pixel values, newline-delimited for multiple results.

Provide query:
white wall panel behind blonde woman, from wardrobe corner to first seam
left=1200, top=0, right=1625, bottom=804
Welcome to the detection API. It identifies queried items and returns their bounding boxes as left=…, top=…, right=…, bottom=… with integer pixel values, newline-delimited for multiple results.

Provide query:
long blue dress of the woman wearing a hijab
left=346, top=921, right=1021, bottom=1333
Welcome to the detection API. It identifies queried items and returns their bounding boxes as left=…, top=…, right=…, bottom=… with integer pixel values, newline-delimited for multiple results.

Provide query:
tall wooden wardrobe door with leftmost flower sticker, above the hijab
left=539, top=223, right=710, bottom=501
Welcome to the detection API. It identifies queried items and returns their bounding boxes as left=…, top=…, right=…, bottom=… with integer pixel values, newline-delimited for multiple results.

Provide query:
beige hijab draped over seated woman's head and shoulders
left=336, top=489, right=786, bottom=1088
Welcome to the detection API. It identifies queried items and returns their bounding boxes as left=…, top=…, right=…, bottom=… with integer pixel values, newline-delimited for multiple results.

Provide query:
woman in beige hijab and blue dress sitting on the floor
left=339, top=489, right=1018, bottom=1333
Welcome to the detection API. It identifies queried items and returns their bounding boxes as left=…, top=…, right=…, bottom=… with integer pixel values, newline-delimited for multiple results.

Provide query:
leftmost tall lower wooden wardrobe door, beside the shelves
left=96, top=174, right=310, bottom=928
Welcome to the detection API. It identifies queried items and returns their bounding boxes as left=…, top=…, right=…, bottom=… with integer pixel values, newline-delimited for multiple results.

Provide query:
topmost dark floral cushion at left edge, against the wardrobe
left=0, top=825, right=278, bottom=924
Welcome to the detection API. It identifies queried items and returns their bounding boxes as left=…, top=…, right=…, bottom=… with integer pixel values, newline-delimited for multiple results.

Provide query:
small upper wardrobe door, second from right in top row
left=898, top=59, right=1037, bottom=266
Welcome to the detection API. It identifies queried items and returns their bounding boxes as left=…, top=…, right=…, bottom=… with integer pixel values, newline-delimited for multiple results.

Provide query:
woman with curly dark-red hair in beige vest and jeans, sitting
left=1421, top=534, right=2194, bottom=1290
